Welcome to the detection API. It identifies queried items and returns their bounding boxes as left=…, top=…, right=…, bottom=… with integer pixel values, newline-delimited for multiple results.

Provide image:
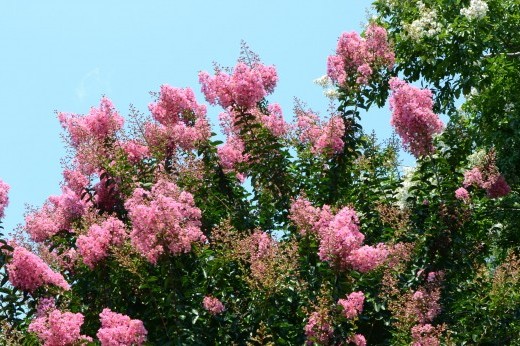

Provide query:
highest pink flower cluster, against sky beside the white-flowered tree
left=327, top=24, right=395, bottom=86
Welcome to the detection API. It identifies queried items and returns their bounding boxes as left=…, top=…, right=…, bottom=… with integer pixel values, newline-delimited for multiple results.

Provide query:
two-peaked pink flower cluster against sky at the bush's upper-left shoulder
left=58, top=97, right=124, bottom=148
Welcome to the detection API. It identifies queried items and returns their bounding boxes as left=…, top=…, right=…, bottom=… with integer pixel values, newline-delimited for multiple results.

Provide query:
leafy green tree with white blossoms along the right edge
left=373, top=0, right=520, bottom=345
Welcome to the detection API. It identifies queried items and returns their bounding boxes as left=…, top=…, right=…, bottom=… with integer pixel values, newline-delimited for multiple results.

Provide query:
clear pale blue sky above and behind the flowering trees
left=0, top=0, right=404, bottom=231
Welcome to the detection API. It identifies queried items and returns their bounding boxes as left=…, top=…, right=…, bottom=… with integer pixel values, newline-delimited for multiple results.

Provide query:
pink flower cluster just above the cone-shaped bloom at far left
left=25, top=186, right=86, bottom=242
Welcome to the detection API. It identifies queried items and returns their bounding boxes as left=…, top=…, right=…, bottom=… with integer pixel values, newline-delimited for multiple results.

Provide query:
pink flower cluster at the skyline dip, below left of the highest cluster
left=296, top=112, right=345, bottom=154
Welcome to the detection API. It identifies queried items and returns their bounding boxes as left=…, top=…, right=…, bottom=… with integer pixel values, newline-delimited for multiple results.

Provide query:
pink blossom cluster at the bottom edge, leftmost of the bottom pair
left=28, top=301, right=92, bottom=346
